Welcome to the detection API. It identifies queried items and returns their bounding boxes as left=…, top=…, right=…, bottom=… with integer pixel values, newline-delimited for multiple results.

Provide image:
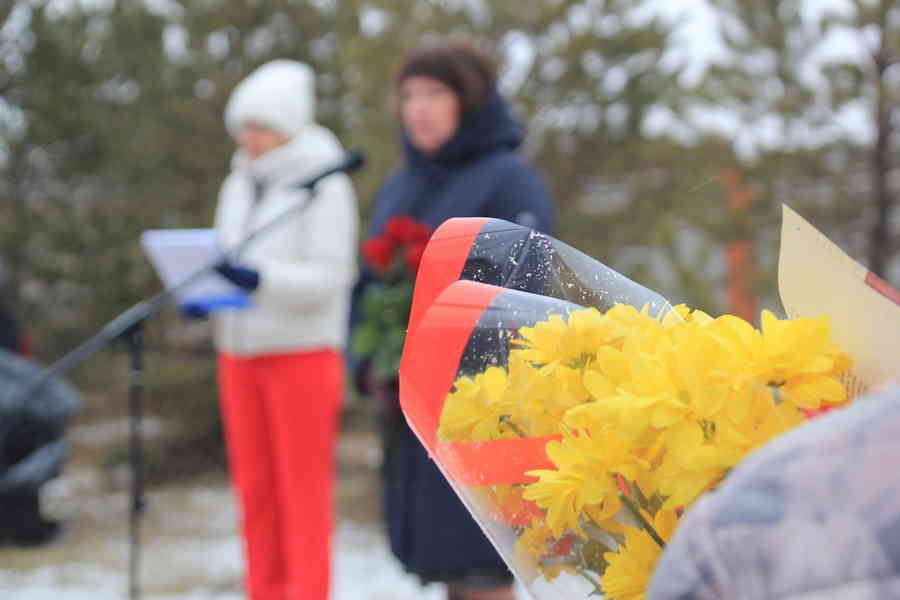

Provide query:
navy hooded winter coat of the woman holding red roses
left=351, top=93, right=555, bottom=581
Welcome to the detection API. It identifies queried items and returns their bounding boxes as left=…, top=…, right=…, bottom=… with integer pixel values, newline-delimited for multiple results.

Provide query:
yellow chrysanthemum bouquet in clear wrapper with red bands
left=401, top=220, right=851, bottom=600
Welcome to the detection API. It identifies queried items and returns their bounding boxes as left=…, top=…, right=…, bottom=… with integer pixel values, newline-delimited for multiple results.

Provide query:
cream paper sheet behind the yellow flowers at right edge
left=778, top=206, right=900, bottom=395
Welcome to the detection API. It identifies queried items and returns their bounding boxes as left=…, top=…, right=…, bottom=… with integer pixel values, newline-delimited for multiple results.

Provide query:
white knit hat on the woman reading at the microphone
left=225, top=59, right=316, bottom=139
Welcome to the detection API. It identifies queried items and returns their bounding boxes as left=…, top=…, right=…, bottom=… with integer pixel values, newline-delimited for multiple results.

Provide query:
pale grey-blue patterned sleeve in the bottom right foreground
left=647, top=389, right=900, bottom=600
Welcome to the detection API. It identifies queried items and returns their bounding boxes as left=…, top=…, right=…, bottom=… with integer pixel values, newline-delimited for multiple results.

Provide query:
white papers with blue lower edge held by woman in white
left=141, top=229, right=246, bottom=303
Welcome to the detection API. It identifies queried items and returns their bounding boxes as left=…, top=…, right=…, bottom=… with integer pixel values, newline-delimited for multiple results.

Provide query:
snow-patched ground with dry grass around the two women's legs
left=0, top=426, right=524, bottom=600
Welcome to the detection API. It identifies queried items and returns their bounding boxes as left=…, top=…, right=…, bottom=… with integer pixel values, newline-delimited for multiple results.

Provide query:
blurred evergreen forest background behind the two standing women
left=0, top=0, right=900, bottom=469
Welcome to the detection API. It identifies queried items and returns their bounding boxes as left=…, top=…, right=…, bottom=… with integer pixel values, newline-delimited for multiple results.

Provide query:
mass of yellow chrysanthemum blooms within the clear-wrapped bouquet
left=439, top=305, right=851, bottom=600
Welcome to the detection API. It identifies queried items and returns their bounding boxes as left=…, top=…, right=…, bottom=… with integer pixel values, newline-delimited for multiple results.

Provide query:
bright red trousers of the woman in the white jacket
left=219, top=350, right=344, bottom=600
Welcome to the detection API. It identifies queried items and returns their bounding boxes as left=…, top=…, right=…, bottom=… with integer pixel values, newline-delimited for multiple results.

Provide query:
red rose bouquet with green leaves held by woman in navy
left=351, top=215, right=431, bottom=381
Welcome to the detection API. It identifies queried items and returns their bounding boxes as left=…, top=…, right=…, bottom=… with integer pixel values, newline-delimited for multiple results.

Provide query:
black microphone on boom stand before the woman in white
left=16, top=151, right=363, bottom=600
